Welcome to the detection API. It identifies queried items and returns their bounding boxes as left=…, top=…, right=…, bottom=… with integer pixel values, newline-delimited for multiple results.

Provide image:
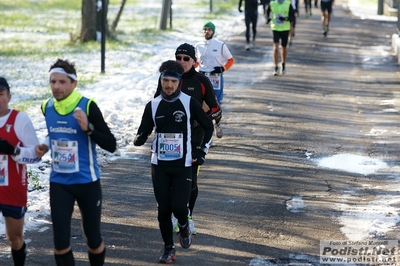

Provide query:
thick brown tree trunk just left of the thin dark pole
left=81, top=0, right=97, bottom=42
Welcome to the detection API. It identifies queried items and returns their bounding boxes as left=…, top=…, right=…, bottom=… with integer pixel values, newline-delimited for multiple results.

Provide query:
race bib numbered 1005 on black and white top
left=158, top=133, right=183, bottom=161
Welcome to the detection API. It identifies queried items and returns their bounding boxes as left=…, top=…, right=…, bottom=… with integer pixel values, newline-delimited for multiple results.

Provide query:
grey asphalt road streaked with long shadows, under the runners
left=0, top=1, right=400, bottom=266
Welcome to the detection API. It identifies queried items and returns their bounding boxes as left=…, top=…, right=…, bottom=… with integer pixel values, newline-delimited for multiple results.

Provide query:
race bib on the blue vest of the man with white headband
left=51, top=139, right=79, bottom=173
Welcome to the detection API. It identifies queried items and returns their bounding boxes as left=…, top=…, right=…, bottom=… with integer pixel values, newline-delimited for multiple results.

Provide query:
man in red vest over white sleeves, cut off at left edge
left=0, top=77, right=40, bottom=266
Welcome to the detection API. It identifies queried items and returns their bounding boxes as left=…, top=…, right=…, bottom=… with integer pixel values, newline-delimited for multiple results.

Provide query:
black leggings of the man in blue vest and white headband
left=50, top=180, right=103, bottom=250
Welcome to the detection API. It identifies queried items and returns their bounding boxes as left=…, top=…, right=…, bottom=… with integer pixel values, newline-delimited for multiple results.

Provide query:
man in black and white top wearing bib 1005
left=134, top=60, right=214, bottom=263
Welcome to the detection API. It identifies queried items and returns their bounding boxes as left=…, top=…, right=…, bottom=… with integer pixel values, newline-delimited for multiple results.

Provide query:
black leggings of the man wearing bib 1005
left=151, top=164, right=192, bottom=246
